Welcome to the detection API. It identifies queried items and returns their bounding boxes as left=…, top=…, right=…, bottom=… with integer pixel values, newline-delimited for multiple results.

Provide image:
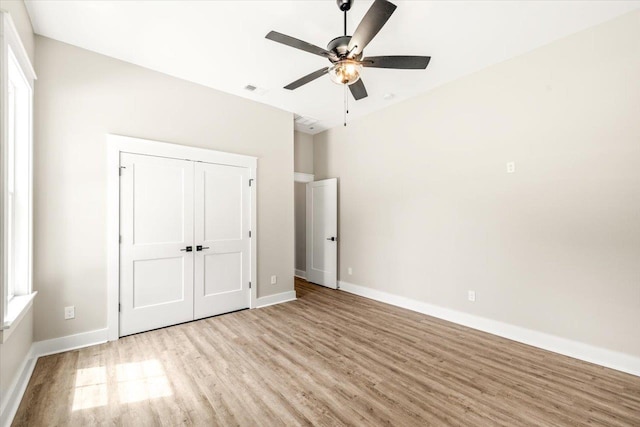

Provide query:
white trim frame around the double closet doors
left=106, top=134, right=258, bottom=341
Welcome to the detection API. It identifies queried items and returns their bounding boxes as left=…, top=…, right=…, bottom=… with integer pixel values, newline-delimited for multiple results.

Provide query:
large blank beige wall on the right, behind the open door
left=314, top=12, right=640, bottom=356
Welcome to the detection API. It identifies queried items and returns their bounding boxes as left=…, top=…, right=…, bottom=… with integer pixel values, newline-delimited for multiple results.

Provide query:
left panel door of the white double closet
left=120, top=153, right=195, bottom=336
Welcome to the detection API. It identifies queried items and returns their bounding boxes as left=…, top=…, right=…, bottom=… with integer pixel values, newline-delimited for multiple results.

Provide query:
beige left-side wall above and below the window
left=0, top=0, right=34, bottom=415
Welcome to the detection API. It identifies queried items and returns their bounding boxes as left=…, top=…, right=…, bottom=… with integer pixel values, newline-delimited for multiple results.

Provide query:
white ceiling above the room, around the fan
left=26, top=0, right=640, bottom=133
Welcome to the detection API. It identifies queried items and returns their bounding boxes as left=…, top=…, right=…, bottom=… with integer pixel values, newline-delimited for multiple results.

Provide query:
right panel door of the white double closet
left=194, top=163, right=251, bottom=319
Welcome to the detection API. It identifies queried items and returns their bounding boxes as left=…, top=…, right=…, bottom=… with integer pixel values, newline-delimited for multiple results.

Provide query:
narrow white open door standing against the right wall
left=307, top=178, right=338, bottom=289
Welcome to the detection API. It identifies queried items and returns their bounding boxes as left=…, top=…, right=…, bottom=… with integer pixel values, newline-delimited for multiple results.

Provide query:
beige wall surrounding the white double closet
left=34, top=36, right=294, bottom=340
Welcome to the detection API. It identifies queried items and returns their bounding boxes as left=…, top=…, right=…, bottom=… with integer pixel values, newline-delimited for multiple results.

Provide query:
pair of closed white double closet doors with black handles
left=120, top=153, right=251, bottom=336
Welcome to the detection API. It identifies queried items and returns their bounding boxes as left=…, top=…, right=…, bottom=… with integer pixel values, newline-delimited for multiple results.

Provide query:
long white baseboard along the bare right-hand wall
left=339, top=281, right=640, bottom=376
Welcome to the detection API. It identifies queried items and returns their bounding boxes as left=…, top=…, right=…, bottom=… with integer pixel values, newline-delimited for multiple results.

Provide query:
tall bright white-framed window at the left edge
left=0, top=12, right=35, bottom=342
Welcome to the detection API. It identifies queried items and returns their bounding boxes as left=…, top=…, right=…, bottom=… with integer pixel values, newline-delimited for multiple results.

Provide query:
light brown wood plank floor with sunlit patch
left=14, top=280, right=640, bottom=426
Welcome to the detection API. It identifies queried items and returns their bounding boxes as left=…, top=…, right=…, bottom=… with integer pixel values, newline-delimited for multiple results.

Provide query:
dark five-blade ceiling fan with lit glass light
left=266, top=0, right=431, bottom=101
